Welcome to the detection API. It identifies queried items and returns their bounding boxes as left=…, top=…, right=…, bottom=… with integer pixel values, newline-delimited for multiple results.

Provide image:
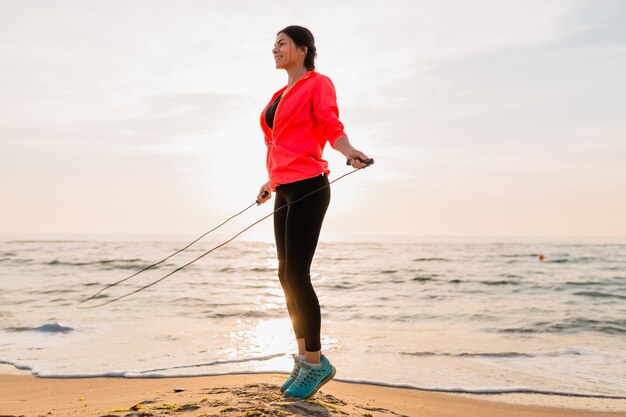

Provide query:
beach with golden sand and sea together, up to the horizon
left=0, top=238, right=626, bottom=417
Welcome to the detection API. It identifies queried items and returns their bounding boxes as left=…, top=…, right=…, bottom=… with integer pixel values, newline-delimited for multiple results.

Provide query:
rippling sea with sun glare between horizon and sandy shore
left=0, top=235, right=626, bottom=399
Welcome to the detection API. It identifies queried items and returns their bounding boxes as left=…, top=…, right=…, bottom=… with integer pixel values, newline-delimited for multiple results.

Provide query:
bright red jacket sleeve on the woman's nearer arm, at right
left=313, top=77, right=347, bottom=146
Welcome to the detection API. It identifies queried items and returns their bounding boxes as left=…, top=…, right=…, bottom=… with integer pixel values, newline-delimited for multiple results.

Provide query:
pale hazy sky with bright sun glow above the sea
left=0, top=0, right=626, bottom=239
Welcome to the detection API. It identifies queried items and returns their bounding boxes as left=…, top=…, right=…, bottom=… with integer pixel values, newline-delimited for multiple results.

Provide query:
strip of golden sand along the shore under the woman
left=0, top=374, right=626, bottom=417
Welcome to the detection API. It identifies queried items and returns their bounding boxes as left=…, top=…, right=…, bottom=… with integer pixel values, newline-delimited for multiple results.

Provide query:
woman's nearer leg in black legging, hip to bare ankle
left=284, top=175, right=330, bottom=364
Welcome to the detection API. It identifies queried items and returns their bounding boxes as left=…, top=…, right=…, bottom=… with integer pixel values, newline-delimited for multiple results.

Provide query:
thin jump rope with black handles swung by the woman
left=76, top=158, right=374, bottom=310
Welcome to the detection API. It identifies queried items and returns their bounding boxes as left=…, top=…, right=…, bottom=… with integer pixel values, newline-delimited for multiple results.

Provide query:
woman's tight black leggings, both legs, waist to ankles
left=274, top=175, right=330, bottom=352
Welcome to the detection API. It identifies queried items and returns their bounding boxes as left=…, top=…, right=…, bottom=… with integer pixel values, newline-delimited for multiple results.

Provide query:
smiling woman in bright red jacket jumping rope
left=257, top=26, right=368, bottom=398
